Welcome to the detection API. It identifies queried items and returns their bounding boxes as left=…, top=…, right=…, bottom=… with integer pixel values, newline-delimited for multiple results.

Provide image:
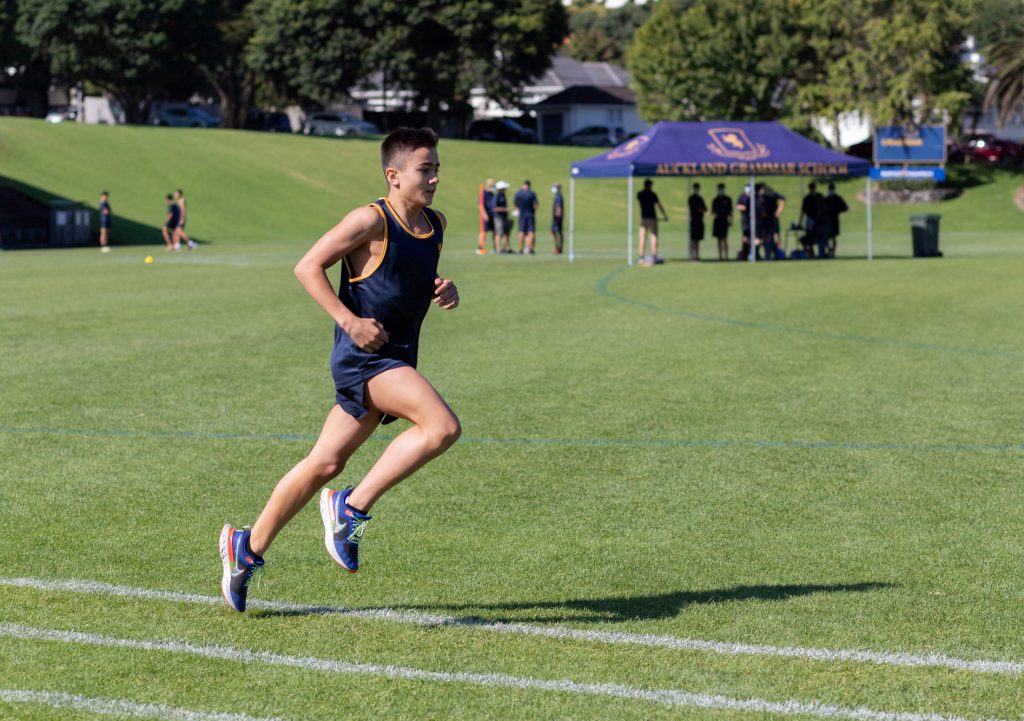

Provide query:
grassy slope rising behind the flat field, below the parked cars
left=0, top=119, right=1024, bottom=257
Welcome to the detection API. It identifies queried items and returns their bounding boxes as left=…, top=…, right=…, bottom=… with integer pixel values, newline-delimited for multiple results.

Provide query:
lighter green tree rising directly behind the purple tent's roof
left=629, top=0, right=812, bottom=122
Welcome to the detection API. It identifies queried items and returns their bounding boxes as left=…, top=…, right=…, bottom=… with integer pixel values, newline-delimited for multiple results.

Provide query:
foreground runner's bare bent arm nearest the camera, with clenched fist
left=295, top=206, right=388, bottom=350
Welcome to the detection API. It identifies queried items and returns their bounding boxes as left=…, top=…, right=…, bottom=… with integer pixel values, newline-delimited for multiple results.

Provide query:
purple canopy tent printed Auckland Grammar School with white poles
left=568, top=120, right=871, bottom=265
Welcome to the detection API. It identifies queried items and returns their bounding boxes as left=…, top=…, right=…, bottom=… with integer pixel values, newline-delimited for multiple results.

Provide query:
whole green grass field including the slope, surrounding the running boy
left=0, top=120, right=1024, bottom=721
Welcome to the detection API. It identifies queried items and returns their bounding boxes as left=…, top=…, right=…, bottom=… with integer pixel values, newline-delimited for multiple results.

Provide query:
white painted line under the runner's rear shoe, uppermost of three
left=0, top=577, right=1024, bottom=676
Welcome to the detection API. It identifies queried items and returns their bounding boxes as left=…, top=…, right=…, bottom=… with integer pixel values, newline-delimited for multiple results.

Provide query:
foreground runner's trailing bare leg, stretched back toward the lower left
left=249, top=406, right=381, bottom=556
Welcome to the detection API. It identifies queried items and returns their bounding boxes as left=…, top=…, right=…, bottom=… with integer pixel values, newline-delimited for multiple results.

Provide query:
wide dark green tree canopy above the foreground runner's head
left=246, top=0, right=567, bottom=128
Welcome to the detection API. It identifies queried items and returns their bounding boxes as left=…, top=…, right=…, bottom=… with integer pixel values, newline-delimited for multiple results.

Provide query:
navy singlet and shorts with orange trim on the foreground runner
left=331, top=198, right=444, bottom=423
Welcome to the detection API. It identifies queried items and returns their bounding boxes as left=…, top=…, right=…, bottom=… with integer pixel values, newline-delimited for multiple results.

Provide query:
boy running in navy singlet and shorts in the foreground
left=220, top=128, right=462, bottom=611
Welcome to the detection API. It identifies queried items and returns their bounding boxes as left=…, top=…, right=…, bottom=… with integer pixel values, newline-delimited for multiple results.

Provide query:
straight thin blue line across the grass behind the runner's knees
left=0, top=427, right=1024, bottom=453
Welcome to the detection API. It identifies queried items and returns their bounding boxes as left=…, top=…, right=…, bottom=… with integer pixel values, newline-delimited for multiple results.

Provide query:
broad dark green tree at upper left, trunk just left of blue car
left=16, top=0, right=206, bottom=122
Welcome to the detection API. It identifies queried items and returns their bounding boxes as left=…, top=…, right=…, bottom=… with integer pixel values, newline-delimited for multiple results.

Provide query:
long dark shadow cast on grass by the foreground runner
left=252, top=582, right=896, bottom=626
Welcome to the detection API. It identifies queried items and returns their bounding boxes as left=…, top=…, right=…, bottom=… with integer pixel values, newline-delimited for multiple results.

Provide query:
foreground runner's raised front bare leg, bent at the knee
left=347, top=366, right=462, bottom=512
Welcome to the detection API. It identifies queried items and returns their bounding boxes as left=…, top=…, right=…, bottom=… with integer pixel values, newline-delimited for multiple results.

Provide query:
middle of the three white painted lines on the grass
left=0, top=623, right=999, bottom=721
